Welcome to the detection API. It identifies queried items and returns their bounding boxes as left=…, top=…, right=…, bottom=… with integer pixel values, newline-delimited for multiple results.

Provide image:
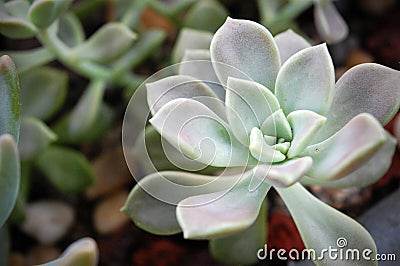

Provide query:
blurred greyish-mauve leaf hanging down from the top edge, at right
left=314, top=1, right=349, bottom=44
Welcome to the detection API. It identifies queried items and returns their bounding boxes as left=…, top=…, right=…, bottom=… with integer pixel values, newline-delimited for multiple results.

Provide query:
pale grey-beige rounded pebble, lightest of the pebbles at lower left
left=22, top=201, right=74, bottom=244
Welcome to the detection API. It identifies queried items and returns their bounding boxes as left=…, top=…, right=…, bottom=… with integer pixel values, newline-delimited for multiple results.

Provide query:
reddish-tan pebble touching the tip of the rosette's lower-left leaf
left=93, top=191, right=129, bottom=234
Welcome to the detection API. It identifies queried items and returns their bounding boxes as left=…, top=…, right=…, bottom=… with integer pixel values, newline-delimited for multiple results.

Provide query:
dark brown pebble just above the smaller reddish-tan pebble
left=86, top=148, right=133, bottom=199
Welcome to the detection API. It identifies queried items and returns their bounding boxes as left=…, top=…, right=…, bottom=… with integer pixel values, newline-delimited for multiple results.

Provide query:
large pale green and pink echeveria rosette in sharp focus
left=123, top=18, right=400, bottom=265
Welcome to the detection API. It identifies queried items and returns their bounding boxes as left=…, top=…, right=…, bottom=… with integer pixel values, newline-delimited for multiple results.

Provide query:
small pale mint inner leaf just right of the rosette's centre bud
left=287, top=110, right=326, bottom=158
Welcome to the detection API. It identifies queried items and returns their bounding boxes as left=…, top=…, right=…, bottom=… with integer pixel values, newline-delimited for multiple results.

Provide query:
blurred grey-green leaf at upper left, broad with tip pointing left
left=72, top=22, right=136, bottom=63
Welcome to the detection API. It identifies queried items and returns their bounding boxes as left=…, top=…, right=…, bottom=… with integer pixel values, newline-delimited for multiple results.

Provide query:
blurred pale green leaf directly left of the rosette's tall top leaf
left=172, top=28, right=213, bottom=63
